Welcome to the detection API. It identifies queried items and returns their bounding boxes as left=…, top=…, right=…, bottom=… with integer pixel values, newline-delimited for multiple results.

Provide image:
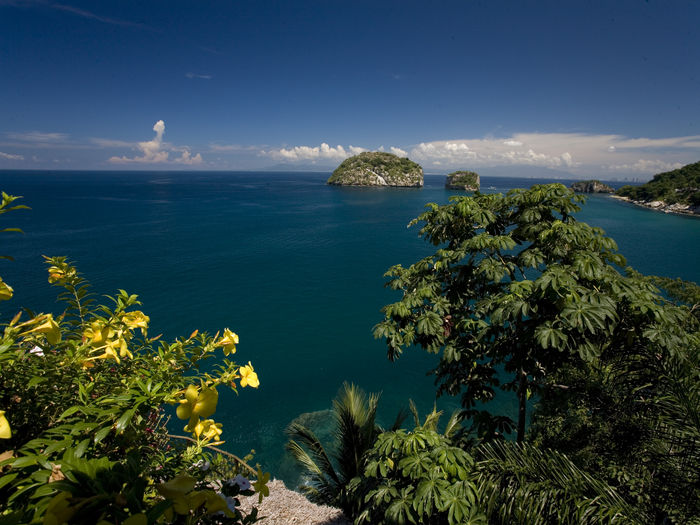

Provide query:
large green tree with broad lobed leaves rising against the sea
left=374, top=184, right=688, bottom=441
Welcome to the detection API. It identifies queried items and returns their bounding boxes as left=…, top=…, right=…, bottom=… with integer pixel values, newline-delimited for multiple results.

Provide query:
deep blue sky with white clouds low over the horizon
left=0, top=0, right=700, bottom=179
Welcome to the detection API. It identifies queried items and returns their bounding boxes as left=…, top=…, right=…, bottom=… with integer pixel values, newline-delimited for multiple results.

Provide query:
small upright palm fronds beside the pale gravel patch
left=287, top=383, right=402, bottom=515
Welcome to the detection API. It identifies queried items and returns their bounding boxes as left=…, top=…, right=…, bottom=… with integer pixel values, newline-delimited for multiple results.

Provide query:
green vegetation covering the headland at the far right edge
left=617, top=162, right=700, bottom=206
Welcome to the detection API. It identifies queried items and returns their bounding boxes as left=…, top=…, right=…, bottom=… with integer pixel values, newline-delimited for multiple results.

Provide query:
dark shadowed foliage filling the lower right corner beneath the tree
left=530, top=272, right=700, bottom=523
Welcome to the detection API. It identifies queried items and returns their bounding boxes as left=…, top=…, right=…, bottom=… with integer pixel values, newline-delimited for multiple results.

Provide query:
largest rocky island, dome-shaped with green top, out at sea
left=327, top=151, right=423, bottom=187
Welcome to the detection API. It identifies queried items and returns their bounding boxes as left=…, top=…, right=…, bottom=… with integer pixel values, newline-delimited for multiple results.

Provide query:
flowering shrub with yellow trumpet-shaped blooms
left=0, top=193, right=269, bottom=525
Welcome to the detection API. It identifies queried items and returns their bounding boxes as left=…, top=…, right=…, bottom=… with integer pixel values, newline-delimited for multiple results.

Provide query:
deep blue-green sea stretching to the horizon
left=0, top=172, right=700, bottom=483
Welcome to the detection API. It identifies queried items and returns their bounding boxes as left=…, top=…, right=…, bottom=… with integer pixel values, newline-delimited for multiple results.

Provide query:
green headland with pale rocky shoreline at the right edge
left=614, top=162, right=700, bottom=215
